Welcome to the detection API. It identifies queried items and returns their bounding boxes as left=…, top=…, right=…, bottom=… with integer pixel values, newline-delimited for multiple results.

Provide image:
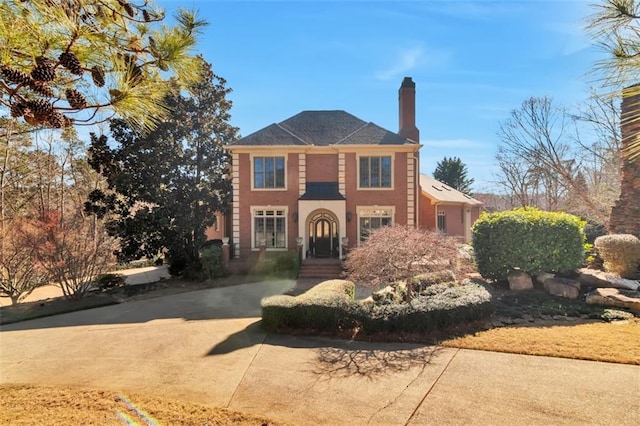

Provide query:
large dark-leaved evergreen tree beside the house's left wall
left=85, top=60, right=237, bottom=271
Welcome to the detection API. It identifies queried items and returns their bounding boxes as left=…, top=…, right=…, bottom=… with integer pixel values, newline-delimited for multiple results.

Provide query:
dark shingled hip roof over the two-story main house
left=229, top=110, right=417, bottom=146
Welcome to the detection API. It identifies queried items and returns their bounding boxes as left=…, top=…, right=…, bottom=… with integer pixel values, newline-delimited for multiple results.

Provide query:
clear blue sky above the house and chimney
left=158, top=0, right=603, bottom=192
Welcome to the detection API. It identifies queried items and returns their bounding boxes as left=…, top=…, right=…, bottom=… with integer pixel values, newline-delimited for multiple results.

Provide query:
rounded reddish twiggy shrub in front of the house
left=345, top=225, right=458, bottom=299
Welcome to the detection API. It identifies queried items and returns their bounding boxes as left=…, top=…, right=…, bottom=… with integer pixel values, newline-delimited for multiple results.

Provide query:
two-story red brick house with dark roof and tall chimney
left=208, top=77, right=481, bottom=259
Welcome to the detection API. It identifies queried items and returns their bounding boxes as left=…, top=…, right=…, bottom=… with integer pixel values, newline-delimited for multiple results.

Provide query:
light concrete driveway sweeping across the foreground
left=0, top=281, right=640, bottom=425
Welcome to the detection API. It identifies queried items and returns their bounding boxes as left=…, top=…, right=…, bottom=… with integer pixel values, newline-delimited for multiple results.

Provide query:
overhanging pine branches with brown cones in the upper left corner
left=0, top=0, right=205, bottom=130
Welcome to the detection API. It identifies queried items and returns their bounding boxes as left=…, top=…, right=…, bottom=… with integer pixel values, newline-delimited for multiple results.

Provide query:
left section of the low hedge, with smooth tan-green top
left=261, top=280, right=357, bottom=331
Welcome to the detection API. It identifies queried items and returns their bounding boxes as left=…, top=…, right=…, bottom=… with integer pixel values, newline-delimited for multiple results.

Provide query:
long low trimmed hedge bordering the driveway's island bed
left=262, top=280, right=495, bottom=333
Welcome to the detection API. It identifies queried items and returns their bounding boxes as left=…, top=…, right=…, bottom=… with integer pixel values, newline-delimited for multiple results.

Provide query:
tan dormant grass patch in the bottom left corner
left=0, top=385, right=278, bottom=425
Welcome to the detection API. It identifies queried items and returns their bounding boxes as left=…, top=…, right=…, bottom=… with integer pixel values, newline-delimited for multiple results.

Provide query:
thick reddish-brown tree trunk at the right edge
left=609, top=88, right=640, bottom=238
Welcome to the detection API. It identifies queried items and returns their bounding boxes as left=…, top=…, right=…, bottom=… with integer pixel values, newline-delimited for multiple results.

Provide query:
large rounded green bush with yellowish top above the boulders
left=472, top=208, right=585, bottom=280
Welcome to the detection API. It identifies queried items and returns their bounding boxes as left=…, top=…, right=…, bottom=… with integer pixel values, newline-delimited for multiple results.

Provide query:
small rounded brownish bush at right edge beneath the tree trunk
left=594, top=234, right=640, bottom=278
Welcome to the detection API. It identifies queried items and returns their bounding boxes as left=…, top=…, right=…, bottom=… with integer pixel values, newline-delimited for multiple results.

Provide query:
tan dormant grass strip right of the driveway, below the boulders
left=441, top=318, right=640, bottom=365
